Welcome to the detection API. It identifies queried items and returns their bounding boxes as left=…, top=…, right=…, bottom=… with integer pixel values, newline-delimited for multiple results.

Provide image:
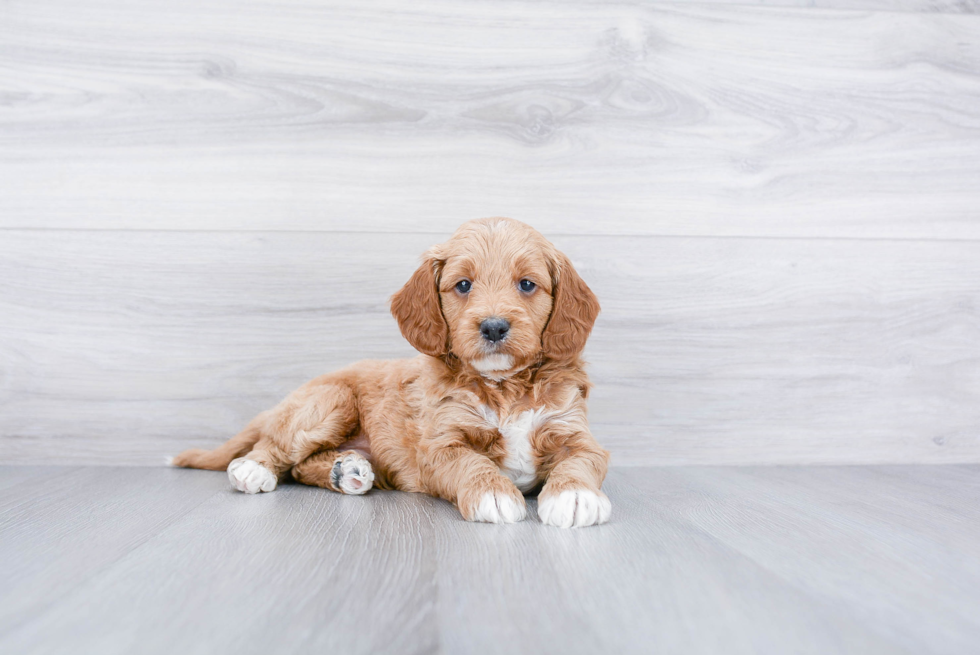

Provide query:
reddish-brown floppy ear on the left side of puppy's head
left=391, top=255, right=449, bottom=357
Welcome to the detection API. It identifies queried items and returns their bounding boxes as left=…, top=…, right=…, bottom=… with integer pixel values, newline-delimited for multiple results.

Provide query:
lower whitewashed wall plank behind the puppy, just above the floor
left=0, top=231, right=980, bottom=465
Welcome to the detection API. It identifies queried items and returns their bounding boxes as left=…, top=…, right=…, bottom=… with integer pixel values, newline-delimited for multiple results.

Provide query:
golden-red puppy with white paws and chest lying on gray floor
left=173, top=218, right=611, bottom=528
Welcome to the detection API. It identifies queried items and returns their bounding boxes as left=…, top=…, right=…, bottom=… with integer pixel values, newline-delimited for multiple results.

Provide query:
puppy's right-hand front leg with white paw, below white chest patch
left=538, top=432, right=612, bottom=528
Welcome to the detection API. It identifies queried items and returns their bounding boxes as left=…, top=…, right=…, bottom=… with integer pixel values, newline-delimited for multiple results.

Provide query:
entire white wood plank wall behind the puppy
left=0, top=0, right=980, bottom=465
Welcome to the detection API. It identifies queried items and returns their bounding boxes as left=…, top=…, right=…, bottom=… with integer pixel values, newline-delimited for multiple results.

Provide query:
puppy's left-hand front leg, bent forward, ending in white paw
left=420, top=444, right=527, bottom=523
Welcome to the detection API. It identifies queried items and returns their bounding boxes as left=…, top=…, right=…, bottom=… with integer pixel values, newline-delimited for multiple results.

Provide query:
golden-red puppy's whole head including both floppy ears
left=391, top=218, right=599, bottom=378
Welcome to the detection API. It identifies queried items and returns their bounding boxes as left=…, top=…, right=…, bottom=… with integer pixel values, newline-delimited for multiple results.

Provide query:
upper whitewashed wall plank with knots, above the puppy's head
left=0, top=0, right=980, bottom=239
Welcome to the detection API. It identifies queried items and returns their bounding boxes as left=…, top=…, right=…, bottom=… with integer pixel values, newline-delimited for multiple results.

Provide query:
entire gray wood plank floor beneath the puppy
left=0, top=465, right=980, bottom=655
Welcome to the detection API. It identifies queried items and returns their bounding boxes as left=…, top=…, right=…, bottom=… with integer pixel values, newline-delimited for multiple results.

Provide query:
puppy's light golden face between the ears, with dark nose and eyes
left=439, top=221, right=554, bottom=377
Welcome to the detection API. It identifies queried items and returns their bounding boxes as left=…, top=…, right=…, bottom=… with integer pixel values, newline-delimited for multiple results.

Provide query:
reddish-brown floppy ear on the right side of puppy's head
left=541, top=252, right=599, bottom=359
